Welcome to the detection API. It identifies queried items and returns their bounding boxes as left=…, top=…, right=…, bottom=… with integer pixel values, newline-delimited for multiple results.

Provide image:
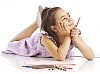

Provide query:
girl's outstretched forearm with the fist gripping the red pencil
left=71, top=27, right=94, bottom=60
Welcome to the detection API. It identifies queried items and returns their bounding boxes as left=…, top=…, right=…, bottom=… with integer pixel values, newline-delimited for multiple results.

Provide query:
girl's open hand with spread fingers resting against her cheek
left=57, top=21, right=70, bottom=37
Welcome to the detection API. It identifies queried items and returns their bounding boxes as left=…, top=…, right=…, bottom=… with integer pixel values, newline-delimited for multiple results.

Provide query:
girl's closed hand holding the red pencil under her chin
left=70, top=26, right=80, bottom=42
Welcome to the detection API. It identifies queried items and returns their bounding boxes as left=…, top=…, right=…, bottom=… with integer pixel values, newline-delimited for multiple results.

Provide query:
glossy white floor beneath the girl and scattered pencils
left=0, top=53, right=100, bottom=74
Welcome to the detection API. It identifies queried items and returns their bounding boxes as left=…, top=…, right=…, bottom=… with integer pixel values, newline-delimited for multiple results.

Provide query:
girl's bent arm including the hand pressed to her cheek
left=41, top=21, right=71, bottom=61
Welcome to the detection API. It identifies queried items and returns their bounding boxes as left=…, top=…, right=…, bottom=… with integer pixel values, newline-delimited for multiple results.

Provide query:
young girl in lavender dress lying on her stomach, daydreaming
left=3, top=7, right=94, bottom=61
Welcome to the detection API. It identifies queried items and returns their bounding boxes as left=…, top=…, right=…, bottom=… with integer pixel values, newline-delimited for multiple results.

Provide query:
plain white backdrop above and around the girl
left=0, top=0, right=100, bottom=54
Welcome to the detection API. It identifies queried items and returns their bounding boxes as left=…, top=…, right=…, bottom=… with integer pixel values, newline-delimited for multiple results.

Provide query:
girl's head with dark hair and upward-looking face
left=41, top=7, right=74, bottom=47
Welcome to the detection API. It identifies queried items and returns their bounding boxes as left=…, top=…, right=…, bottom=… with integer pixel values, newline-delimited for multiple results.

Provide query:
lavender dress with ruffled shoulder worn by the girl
left=3, top=17, right=74, bottom=57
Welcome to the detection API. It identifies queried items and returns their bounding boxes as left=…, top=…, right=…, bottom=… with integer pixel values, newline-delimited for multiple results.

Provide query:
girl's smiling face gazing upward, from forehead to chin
left=55, top=9, right=74, bottom=30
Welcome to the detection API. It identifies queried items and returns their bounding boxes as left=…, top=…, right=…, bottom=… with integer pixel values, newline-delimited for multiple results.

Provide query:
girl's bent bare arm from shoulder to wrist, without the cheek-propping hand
left=41, top=35, right=71, bottom=61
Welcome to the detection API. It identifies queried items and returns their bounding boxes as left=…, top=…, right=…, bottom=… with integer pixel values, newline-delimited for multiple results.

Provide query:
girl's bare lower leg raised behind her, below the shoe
left=11, top=22, right=38, bottom=42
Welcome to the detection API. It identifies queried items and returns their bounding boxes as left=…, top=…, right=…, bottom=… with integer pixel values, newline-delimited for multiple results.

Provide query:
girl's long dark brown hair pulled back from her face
left=41, top=7, right=61, bottom=47
